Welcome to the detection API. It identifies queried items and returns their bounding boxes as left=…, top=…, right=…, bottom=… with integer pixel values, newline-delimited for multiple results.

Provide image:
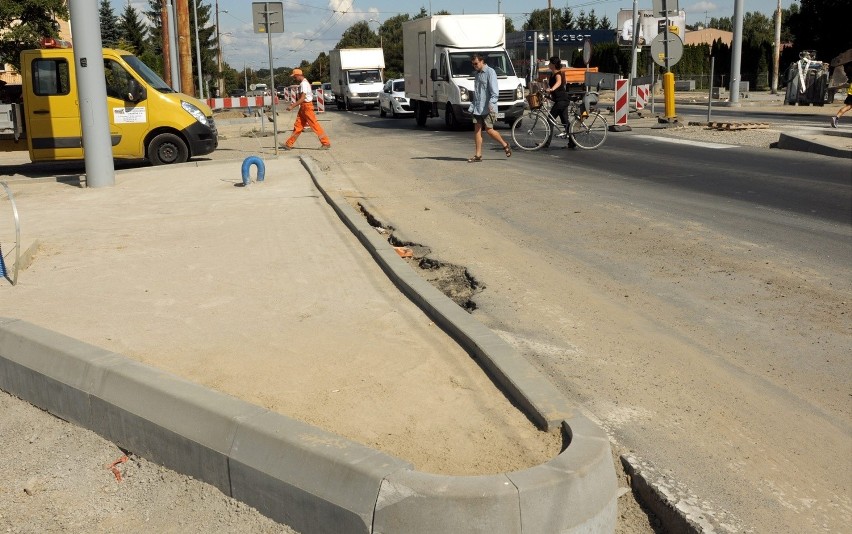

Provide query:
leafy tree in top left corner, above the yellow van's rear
left=0, top=0, right=69, bottom=70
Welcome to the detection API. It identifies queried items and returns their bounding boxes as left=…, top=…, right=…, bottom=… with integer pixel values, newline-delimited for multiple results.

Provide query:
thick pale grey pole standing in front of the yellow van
left=69, top=0, right=115, bottom=187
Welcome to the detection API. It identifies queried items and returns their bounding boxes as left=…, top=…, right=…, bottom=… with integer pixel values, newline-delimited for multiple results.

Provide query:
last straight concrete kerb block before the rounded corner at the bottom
left=230, top=412, right=411, bottom=534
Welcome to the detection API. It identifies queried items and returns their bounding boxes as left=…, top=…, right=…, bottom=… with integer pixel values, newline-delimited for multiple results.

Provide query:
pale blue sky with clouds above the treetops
left=111, top=0, right=793, bottom=70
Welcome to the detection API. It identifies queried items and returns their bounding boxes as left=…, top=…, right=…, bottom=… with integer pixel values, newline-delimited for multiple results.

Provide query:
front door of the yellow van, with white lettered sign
left=104, top=58, right=148, bottom=158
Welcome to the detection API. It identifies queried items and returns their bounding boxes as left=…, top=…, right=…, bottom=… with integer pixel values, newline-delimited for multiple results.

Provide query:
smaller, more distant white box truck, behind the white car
left=329, top=48, right=385, bottom=109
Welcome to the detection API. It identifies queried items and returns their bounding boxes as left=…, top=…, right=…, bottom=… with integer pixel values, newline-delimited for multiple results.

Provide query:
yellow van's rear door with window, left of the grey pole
left=24, top=56, right=83, bottom=161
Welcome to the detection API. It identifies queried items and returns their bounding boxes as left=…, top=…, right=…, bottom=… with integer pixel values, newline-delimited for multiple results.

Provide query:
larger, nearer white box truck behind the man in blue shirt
left=402, top=14, right=524, bottom=128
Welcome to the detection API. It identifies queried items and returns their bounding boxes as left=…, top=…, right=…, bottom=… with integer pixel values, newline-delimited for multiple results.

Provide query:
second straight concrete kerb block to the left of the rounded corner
left=90, top=357, right=265, bottom=495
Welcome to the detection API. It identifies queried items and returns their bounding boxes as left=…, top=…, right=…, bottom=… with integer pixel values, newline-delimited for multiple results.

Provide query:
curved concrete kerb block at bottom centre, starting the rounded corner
left=373, top=471, right=530, bottom=534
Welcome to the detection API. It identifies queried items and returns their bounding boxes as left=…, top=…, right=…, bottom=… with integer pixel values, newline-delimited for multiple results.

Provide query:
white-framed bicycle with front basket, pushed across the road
left=512, top=92, right=608, bottom=151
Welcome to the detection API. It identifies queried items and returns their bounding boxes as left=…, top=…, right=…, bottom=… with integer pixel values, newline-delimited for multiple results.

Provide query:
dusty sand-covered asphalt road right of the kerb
left=306, top=111, right=852, bottom=532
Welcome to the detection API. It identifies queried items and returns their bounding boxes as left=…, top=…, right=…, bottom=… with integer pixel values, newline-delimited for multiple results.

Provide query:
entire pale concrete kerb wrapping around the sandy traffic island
left=0, top=159, right=617, bottom=534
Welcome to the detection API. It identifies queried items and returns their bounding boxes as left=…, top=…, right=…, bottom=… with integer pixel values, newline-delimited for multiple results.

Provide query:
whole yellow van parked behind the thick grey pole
left=0, top=48, right=218, bottom=165
